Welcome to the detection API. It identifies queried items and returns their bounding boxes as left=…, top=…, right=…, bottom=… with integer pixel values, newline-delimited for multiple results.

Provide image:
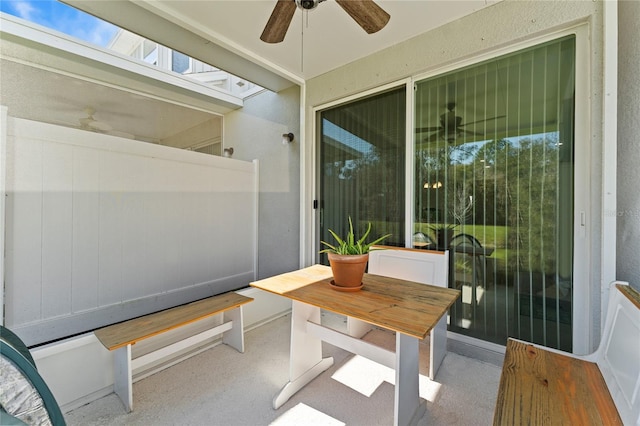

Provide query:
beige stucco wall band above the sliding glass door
left=306, top=0, right=602, bottom=107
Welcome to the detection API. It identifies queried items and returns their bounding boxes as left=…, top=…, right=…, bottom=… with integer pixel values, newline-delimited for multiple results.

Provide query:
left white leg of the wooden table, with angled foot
left=273, top=300, right=333, bottom=409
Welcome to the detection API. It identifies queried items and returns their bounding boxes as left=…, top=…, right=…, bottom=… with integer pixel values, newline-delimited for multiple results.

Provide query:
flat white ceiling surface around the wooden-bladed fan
left=131, top=0, right=496, bottom=80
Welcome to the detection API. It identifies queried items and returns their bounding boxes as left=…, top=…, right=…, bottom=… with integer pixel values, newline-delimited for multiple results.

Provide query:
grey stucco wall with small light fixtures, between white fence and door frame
left=221, top=86, right=300, bottom=279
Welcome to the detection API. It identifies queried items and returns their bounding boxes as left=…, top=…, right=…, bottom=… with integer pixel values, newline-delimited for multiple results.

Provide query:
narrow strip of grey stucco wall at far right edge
left=616, top=0, right=640, bottom=289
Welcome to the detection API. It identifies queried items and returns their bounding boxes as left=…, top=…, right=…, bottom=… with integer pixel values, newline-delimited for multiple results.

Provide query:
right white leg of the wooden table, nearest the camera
left=393, top=333, right=426, bottom=426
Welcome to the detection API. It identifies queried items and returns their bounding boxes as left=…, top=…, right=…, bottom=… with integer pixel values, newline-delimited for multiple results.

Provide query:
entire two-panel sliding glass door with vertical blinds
left=316, top=36, right=576, bottom=351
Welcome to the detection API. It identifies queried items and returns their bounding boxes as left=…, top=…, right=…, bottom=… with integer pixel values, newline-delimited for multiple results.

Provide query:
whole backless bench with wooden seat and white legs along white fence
left=94, top=292, right=253, bottom=412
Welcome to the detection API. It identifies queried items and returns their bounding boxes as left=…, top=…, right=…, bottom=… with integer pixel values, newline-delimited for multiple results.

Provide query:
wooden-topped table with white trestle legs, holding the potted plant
left=251, top=265, right=460, bottom=425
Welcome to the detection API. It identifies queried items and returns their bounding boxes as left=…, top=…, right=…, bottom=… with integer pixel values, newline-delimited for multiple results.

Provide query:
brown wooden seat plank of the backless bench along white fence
left=95, top=292, right=253, bottom=351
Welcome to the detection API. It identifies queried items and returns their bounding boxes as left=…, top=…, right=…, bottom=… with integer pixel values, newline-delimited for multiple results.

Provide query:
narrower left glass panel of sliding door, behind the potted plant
left=317, top=86, right=406, bottom=264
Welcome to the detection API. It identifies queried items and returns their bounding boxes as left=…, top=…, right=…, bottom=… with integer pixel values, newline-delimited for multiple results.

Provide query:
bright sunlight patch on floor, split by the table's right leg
left=331, top=355, right=442, bottom=402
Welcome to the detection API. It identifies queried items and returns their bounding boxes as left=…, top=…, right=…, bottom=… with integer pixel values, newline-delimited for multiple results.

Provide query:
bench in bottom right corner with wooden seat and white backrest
left=493, top=281, right=640, bottom=426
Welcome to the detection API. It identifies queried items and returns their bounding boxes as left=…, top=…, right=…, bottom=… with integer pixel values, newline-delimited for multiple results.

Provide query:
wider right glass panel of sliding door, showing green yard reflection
left=414, top=37, right=575, bottom=351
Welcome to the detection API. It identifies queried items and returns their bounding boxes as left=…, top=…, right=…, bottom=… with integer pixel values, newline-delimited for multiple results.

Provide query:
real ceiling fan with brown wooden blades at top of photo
left=260, top=0, right=390, bottom=43
